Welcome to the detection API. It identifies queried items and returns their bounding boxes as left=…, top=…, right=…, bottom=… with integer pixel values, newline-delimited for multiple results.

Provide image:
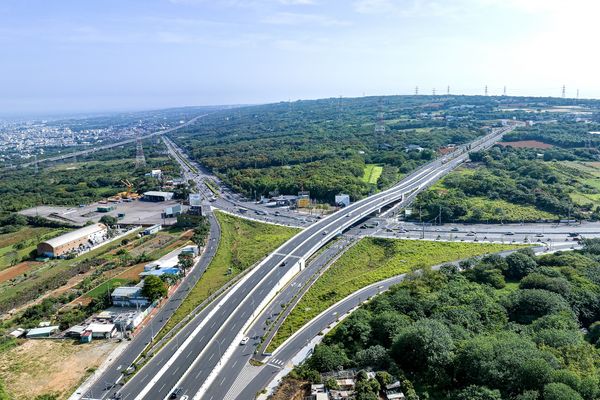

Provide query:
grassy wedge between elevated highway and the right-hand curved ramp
left=267, top=238, right=515, bottom=352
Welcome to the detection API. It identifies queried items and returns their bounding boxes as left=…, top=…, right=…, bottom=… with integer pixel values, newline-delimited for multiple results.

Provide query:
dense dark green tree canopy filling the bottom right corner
left=292, top=240, right=600, bottom=400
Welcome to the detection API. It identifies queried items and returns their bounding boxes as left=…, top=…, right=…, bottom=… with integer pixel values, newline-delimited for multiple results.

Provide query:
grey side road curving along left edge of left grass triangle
left=82, top=209, right=221, bottom=399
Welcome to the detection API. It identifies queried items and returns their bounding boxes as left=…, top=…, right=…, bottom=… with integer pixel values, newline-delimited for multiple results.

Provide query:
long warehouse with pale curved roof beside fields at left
left=37, top=224, right=108, bottom=257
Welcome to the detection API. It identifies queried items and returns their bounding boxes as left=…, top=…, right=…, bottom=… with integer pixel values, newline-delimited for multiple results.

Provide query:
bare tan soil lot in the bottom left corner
left=0, top=340, right=117, bottom=400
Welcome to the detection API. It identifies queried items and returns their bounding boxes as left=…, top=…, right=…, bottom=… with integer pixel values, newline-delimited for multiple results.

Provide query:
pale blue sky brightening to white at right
left=0, top=0, right=600, bottom=113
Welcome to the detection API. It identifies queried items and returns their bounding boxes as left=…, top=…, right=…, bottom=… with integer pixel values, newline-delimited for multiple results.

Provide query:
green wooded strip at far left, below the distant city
left=0, top=140, right=179, bottom=216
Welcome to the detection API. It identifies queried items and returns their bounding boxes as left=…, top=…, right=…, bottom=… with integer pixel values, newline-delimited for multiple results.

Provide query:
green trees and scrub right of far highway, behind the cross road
left=414, top=124, right=600, bottom=222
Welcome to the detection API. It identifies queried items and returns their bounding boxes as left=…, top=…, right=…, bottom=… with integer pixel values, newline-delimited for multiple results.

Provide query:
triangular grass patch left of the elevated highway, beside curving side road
left=152, top=212, right=298, bottom=338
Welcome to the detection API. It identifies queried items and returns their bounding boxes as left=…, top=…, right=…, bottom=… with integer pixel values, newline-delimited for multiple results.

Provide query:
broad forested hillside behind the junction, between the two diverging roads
left=173, top=96, right=502, bottom=201
